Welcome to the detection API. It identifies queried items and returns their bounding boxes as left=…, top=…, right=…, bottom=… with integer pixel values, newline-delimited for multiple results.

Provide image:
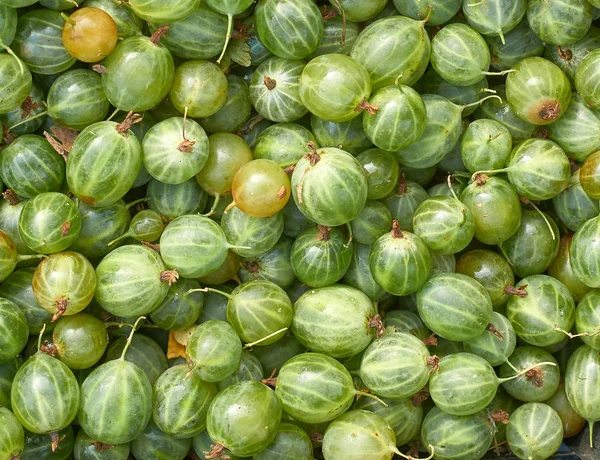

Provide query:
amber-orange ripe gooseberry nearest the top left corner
left=62, top=8, right=118, bottom=62
